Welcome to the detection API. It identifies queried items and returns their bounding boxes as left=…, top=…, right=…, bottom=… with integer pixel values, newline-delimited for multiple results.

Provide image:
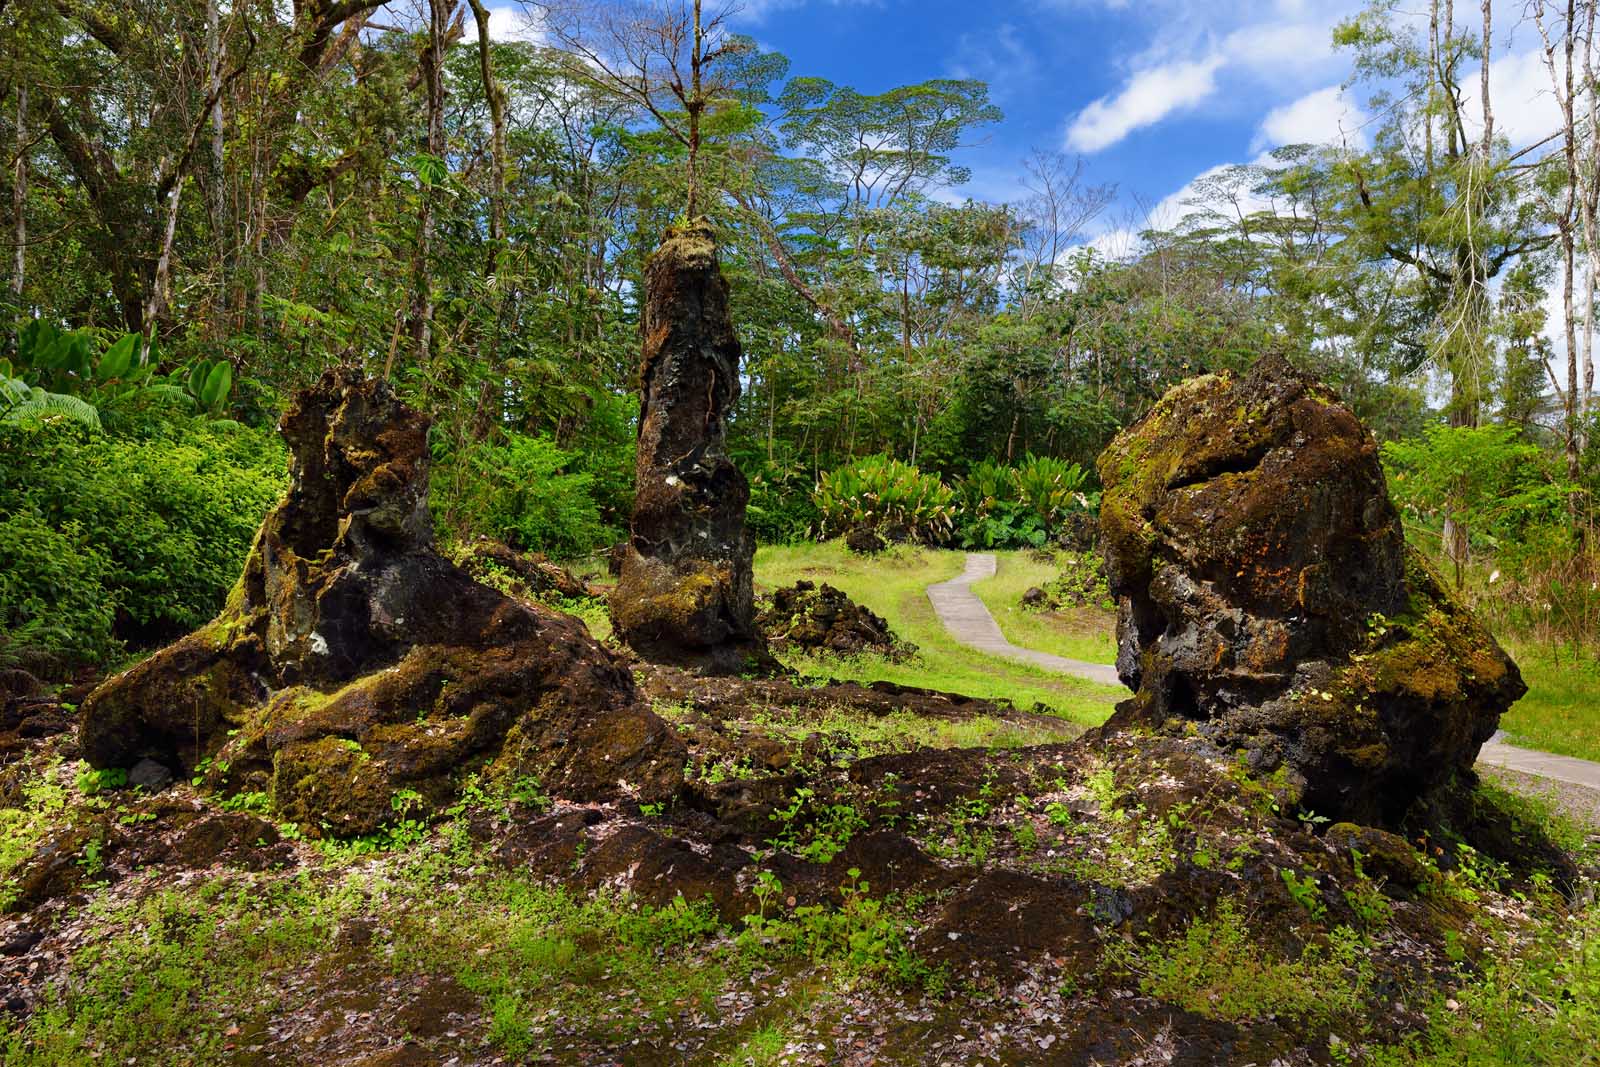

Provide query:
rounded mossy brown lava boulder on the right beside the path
left=1099, top=357, right=1526, bottom=825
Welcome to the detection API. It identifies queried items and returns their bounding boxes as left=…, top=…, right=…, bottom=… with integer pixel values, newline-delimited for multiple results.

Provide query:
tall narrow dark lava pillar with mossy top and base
left=611, top=219, right=766, bottom=673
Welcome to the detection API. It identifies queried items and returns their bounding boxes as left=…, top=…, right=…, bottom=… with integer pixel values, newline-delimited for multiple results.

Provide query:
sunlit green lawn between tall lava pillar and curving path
left=755, top=541, right=1126, bottom=726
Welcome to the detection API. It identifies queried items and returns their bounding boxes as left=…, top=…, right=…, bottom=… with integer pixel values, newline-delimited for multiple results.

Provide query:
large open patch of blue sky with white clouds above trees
left=726, top=0, right=1355, bottom=225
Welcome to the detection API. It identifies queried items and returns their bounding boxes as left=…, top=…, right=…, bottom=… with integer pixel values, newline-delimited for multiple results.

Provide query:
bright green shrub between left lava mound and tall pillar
left=434, top=434, right=619, bottom=558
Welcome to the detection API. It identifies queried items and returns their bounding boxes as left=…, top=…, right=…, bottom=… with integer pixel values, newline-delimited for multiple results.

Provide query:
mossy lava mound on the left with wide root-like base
left=80, top=371, right=685, bottom=837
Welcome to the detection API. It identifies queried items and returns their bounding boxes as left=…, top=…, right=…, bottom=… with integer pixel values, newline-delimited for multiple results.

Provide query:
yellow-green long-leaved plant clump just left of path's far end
left=813, top=456, right=955, bottom=544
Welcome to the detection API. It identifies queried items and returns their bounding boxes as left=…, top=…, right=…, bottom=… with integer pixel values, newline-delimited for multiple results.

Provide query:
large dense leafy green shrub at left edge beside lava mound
left=0, top=413, right=285, bottom=662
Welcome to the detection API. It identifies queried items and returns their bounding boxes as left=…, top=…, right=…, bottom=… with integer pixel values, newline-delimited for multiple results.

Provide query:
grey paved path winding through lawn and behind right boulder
left=928, top=552, right=1600, bottom=790
